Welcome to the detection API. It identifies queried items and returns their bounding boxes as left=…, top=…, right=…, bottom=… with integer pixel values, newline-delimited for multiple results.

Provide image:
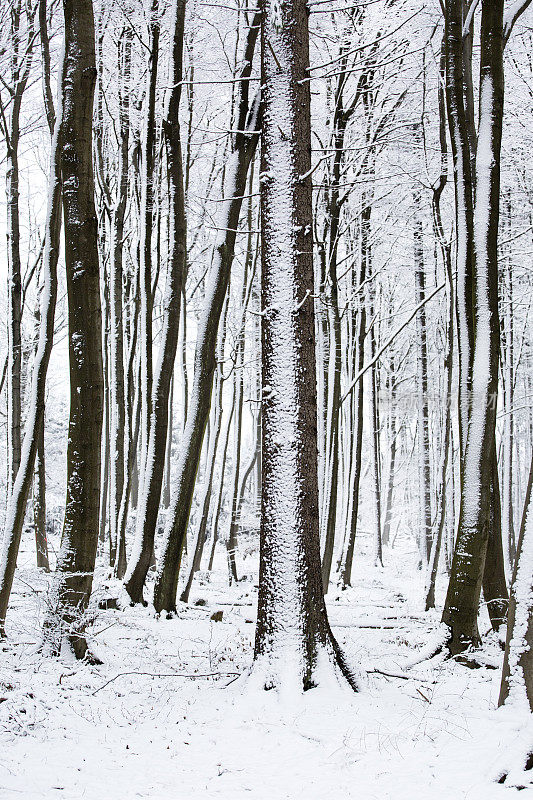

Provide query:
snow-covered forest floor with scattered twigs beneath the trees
left=0, top=542, right=533, bottom=800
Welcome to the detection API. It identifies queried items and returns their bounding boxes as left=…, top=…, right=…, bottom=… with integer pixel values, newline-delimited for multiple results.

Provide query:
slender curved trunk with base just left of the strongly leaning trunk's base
left=124, top=0, right=187, bottom=603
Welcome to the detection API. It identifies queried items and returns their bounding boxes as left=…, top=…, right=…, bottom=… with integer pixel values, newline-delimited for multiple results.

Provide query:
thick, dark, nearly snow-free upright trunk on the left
left=45, top=0, right=103, bottom=658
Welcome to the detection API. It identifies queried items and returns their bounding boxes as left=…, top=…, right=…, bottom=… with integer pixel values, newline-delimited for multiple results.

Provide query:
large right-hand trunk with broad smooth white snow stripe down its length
left=443, top=0, right=503, bottom=653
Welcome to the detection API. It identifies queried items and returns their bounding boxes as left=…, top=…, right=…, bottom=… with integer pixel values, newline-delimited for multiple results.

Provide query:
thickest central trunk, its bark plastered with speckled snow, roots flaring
left=252, top=0, right=356, bottom=692
